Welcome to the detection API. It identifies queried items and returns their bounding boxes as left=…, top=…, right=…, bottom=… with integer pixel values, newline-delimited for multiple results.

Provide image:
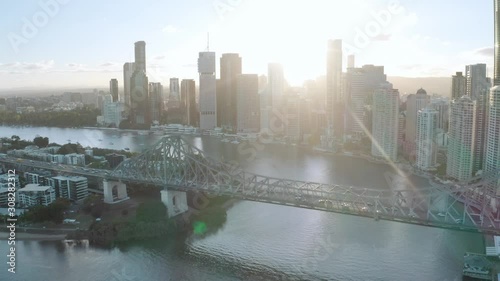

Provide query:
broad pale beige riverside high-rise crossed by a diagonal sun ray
left=371, top=83, right=399, bottom=162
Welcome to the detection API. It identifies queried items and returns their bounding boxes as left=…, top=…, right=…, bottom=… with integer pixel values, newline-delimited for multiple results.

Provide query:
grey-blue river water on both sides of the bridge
left=0, top=127, right=484, bottom=281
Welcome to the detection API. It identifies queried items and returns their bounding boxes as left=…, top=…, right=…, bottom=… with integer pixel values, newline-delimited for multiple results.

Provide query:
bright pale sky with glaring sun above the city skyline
left=0, top=0, right=494, bottom=89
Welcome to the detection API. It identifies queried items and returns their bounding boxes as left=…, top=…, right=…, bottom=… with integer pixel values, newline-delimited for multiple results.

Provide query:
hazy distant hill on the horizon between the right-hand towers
left=387, top=76, right=451, bottom=97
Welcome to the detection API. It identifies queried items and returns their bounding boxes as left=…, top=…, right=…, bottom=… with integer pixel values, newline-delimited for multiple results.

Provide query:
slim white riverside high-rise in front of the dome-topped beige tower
left=416, top=107, right=438, bottom=170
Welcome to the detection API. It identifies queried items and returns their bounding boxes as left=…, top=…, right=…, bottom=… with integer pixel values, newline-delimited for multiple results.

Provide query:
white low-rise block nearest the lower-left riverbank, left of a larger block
left=19, top=183, right=56, bottom=208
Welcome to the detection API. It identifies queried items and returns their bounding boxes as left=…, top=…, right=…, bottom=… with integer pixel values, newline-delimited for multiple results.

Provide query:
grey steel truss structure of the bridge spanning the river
left=107, top=136, right=500, bottom=233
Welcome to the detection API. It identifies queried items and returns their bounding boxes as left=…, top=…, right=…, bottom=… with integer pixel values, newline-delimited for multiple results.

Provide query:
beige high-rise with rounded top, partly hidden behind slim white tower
left=405, top=88, right=431, bottom=150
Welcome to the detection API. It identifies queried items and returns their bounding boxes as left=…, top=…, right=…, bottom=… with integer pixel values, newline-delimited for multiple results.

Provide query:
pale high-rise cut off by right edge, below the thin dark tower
left=484, top=86, right=500, bottom=195
